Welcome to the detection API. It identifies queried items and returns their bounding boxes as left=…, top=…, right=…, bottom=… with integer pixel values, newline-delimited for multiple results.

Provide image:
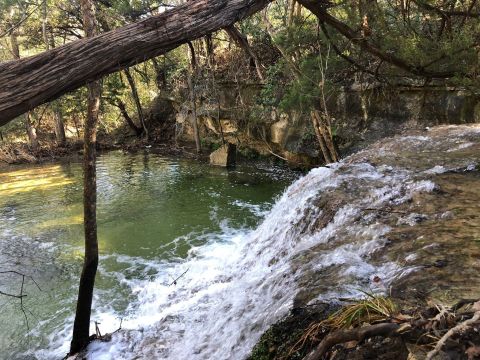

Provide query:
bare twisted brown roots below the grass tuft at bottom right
left=286, top=299, right=480, bottom=360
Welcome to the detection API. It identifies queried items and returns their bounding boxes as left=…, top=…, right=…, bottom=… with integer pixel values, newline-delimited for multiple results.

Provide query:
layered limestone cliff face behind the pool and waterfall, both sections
left=157, top=83, right=480, bottom=167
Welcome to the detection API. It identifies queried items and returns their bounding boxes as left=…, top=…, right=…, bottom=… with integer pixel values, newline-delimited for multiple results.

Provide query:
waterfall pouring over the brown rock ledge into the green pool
left=44, top=127, right=480, bottom=359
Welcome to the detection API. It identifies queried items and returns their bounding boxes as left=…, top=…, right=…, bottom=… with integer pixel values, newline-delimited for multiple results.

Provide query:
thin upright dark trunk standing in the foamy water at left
left=70, top=0, right=101, bottom=355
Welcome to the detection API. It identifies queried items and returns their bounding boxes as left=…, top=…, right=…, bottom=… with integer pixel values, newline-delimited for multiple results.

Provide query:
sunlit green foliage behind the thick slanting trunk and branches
left=0, top=0, right=480, bottom=144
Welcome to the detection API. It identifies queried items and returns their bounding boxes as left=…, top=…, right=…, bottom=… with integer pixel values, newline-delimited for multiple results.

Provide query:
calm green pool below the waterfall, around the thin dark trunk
left=0, top=153, right=296, bottom=359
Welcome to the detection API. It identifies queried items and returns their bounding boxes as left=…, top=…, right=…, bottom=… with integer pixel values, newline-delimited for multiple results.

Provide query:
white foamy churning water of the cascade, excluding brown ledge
left=30, top=157, right=444, bottom=360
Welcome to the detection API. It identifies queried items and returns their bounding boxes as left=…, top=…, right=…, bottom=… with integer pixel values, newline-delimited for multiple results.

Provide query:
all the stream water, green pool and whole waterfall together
left=1, top=126, right=480, bottom=359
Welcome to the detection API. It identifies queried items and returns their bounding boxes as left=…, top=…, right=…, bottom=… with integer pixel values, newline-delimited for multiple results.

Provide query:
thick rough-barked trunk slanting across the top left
left=0, top=0, right=272, bottom=126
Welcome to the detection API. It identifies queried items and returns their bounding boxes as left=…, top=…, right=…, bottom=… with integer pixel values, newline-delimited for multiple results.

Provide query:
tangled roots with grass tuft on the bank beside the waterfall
left=283, top=294, right=480, bottom=360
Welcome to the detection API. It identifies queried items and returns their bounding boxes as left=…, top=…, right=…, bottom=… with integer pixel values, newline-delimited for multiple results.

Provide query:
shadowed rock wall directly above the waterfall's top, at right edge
left=334, top=85, right=480, bottom=153
